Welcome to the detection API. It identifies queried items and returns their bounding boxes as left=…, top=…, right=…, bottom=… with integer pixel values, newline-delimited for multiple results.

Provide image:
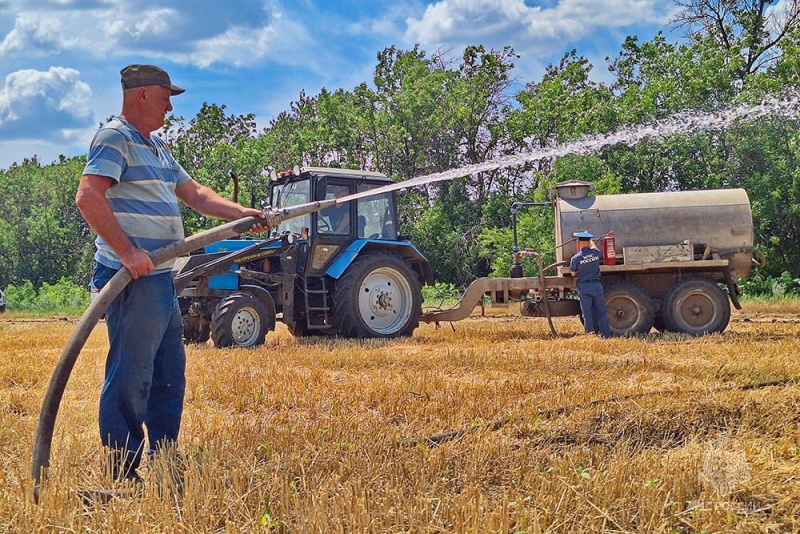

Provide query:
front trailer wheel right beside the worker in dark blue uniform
left=605, top=280, right=655, bottom=336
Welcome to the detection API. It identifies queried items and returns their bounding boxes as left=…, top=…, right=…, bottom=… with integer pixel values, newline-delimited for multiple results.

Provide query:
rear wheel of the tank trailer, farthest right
left=664, top=278, right=731, bottom=336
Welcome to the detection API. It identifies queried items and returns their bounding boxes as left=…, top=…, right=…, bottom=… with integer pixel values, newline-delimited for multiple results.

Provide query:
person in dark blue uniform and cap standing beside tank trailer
left=569, top=232, right=611, bottom=338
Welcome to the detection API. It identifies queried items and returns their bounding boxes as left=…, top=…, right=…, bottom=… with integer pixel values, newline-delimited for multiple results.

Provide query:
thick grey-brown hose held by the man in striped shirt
left=31, top=197, right=334, bottom=503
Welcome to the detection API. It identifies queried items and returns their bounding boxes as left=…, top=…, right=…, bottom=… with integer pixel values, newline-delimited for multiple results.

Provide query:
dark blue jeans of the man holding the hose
left=92, top=263, right=186, bottom=478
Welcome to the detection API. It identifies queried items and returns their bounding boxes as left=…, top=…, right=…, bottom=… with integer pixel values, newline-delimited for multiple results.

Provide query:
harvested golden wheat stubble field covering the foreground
left=0, top=305, right=800, bottom=533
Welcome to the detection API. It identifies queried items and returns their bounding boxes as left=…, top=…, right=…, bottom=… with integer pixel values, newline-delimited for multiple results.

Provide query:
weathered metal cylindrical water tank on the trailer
left=553, top=180, right=753, bottom=280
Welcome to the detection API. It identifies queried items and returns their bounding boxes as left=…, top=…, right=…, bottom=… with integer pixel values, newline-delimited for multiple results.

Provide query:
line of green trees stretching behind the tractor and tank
left=0, top=0, right=800, bottom=300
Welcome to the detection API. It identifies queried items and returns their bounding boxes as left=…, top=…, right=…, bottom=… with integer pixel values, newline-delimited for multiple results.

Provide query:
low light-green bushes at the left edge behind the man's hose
left=6, top=278, right=90, bottom=312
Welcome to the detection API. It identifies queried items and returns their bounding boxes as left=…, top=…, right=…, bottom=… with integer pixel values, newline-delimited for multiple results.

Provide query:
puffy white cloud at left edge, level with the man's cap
left=0, top=67, right=92, bottom=138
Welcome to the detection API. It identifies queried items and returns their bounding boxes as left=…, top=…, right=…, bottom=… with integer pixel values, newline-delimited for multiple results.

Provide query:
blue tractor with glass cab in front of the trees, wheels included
left=173, top=167, right=433, bottom=347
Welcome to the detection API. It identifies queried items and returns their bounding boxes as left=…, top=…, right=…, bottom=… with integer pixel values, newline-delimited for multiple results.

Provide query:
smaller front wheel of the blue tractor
left=211, top=292, right=270, bottom=348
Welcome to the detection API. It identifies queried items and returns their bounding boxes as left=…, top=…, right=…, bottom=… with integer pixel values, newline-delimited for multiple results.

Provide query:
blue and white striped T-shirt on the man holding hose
left=83, top=117, right=191, bottom=272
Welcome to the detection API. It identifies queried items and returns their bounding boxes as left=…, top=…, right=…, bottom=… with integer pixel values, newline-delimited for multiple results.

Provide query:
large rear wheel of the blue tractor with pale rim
left=333, top=252, right=422, bottom=338
